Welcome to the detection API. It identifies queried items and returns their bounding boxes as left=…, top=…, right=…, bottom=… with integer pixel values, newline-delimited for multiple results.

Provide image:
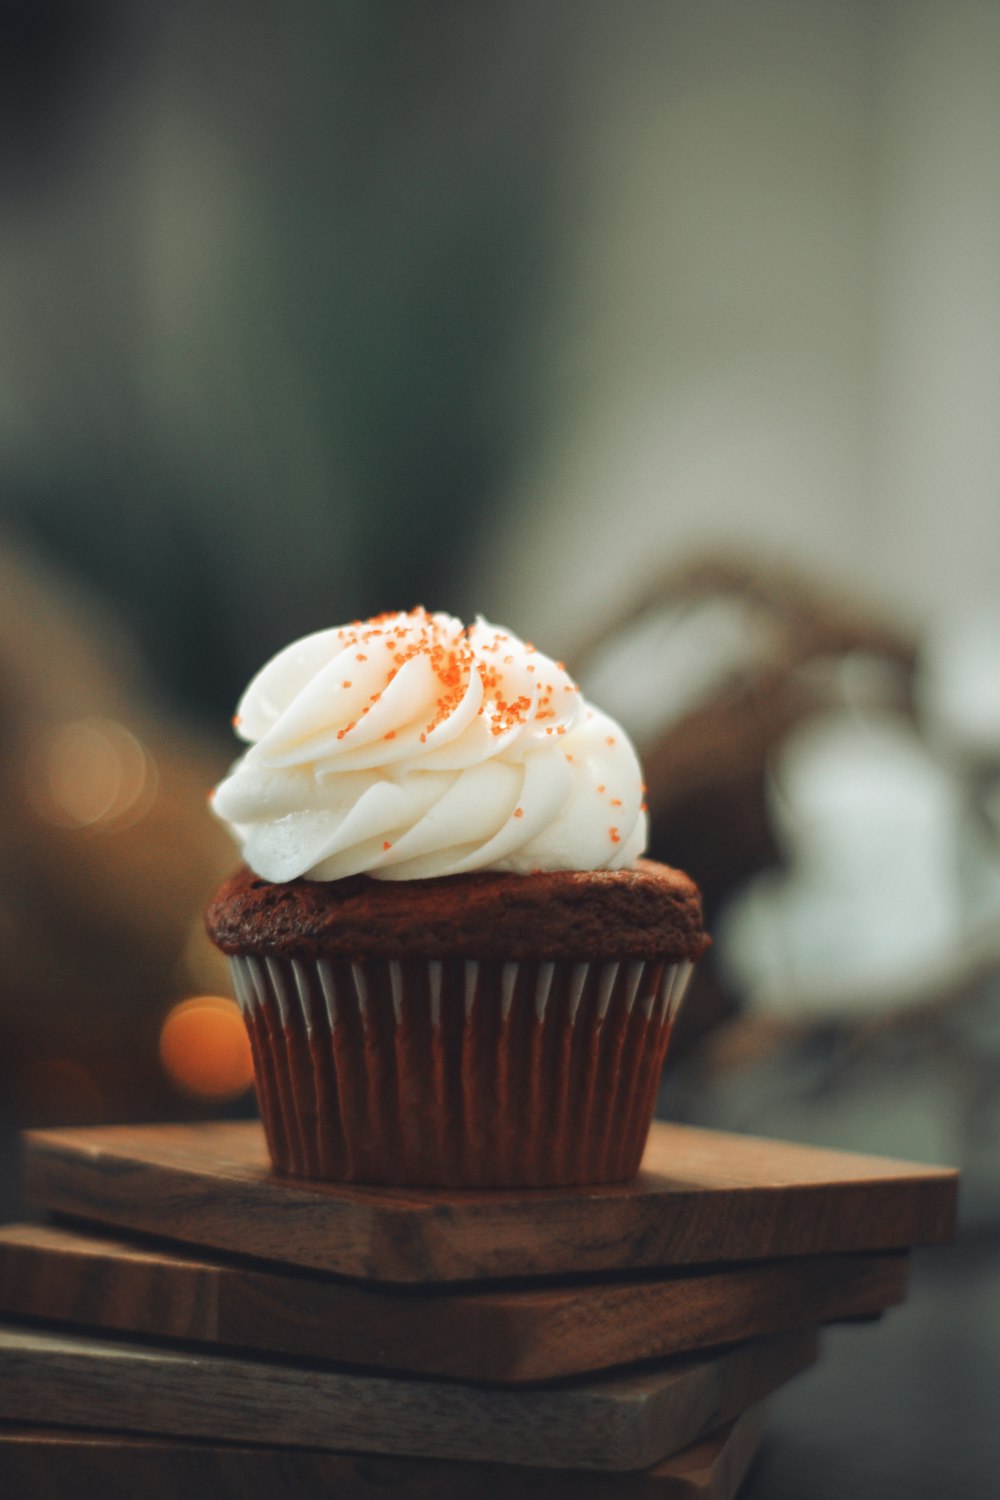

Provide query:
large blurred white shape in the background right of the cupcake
left=718, top=711, right=963, bottom=1019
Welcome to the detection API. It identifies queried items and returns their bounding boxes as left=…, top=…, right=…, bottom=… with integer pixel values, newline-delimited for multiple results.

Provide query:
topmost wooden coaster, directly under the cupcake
left=24, top=1122, right=957, bottom=1283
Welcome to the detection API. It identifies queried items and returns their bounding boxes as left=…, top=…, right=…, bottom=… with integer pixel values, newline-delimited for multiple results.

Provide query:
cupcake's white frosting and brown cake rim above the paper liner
left=207, top=609, right=708, bottom=962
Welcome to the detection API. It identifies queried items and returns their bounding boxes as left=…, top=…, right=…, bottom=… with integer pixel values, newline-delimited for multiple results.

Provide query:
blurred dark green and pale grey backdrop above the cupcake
left=0, top=0, right=1000, bottom=723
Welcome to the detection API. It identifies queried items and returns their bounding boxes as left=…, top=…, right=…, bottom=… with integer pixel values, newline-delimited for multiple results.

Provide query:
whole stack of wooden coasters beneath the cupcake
left=0, top=1124, right=955, bottom=1500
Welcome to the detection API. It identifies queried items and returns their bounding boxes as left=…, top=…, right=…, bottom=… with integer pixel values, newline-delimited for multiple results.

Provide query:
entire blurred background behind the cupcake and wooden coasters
left=0, top=0, right=1000, bottom=1227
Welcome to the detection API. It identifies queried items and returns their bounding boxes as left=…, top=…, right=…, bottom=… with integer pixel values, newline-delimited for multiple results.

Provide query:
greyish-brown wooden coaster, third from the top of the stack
left=0, top=1325, right=816, bottom=1470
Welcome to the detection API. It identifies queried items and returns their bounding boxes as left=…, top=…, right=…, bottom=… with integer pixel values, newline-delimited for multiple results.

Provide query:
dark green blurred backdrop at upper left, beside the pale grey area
left=0, top=0, right=576, bottom=722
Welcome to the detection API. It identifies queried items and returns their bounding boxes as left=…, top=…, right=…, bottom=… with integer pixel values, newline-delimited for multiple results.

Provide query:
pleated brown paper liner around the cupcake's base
left=229, top=956, right=691, bottom=1187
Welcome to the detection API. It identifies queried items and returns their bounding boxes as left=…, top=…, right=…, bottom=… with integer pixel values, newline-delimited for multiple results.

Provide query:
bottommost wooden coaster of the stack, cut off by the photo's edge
left=0, top=1404, right=765, bottom=1500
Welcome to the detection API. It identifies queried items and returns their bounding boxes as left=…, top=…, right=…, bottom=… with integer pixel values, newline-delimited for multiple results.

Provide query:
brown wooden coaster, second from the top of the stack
left=0, top=1224, right=907, bottom=1382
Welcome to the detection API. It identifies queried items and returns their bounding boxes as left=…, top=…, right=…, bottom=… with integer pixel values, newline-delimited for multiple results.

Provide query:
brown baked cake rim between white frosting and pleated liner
left=205, top=860, right=709, bottom=963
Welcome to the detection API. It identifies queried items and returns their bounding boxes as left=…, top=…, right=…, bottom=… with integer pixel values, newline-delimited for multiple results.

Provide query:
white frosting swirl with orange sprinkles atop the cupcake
left=213, top=609, right=646, bottom=881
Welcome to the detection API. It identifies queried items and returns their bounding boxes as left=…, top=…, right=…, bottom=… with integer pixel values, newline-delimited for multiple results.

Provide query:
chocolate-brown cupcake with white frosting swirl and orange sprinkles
left=207, top=609, right=708, bottom=1187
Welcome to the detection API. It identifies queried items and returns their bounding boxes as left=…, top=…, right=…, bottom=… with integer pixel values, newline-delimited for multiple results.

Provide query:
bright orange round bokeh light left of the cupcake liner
left=160, top=995, right=253, bottom=1100
